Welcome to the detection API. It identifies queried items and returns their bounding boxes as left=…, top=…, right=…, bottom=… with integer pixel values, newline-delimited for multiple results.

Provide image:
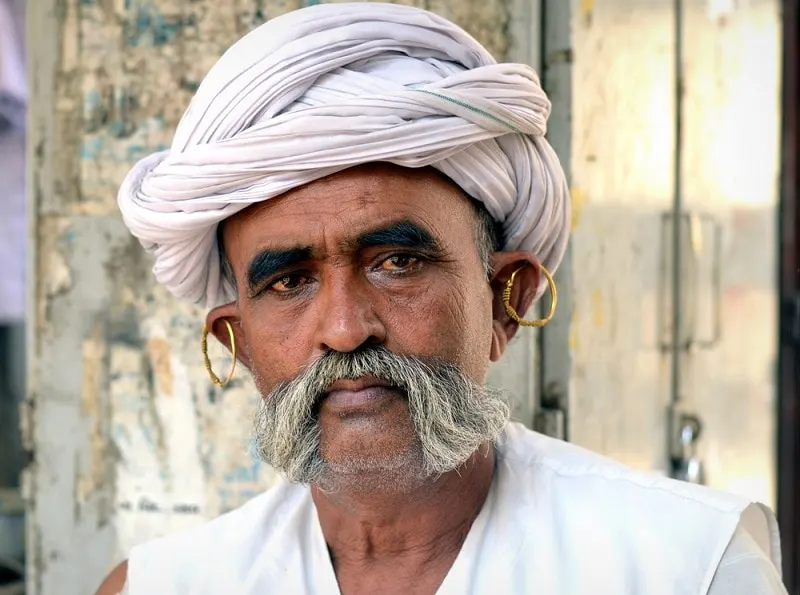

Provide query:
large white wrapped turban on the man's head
left=119, top=3, right=569, bottom=307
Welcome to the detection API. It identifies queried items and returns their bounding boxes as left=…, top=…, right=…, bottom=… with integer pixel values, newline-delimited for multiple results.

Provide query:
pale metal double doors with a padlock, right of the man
left=570, top=0, right=780, bottom=505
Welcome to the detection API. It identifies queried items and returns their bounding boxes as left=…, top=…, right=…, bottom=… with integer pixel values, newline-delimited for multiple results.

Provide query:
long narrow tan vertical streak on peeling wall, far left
left=75, top=321, right=106, bottom=503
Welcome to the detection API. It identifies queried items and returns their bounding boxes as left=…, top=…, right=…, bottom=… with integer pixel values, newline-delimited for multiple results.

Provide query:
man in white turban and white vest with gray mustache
left=99, top=4, right=784, bottom=595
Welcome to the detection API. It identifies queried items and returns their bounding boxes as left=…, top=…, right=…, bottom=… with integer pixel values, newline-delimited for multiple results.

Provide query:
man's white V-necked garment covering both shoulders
left=123, top=424, right=785, bottom=595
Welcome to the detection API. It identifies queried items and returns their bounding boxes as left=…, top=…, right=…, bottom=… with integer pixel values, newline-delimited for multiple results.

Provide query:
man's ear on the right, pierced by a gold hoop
left=490, top=251, right=542, bottom=361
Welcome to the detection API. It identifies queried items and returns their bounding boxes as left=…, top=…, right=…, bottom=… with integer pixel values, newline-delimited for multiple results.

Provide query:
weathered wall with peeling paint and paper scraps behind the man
left=24, top=0, right=537, bottom=595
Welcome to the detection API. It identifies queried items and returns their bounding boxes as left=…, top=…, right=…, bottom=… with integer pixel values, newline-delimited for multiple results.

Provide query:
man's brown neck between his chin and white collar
left=312, top=445, right=495, bottom=574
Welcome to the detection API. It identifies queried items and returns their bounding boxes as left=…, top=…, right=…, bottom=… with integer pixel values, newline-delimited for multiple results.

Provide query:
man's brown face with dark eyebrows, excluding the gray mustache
left=216, top=165, right=520, bottom=492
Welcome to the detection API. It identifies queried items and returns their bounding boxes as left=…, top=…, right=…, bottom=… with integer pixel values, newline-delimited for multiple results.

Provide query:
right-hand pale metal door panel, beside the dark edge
left=678, top=0, right=781, bottom=507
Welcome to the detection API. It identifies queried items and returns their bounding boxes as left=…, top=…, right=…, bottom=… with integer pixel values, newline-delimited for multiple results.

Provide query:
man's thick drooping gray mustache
left=255, top=346, right=509, bottom=484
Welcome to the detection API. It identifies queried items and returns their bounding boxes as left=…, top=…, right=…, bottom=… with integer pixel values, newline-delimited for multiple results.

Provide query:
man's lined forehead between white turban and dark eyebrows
left=223, top=164, right=474, bottom=261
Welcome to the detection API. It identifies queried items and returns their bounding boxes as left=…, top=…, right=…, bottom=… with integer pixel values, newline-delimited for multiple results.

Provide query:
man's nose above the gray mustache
left=315, top=270, right=386, bottom=353
